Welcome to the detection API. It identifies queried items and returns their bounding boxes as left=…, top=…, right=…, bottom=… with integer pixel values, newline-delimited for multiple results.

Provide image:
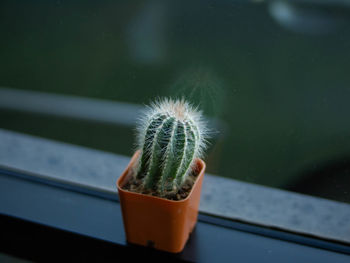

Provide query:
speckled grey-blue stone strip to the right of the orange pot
left=201, top=176, right=350, bottom=242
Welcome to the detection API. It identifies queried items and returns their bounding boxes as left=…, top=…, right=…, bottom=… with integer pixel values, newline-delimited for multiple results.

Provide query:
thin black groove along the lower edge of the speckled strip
left=0, top=167, right=350, bottom=254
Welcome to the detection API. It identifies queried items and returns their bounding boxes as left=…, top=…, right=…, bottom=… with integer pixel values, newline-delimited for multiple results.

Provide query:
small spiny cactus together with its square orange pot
left=117, top=99, right=207, bottom=253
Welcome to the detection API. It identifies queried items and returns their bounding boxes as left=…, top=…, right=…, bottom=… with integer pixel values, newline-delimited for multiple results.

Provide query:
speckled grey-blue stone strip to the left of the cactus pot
left=0, top=129, right=129, bottom=191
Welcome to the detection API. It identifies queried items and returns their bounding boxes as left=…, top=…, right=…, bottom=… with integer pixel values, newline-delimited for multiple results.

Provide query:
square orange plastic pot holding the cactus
left=117, top=151, right=205, bottom=253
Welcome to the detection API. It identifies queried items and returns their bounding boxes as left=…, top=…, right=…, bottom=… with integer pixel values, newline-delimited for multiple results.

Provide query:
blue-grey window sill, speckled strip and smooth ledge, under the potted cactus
left=0, top=130, right=350, bottom=261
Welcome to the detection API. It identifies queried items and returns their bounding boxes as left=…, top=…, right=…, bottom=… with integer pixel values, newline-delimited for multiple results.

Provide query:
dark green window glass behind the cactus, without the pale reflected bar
left=0, top=0, right=350, bottom=202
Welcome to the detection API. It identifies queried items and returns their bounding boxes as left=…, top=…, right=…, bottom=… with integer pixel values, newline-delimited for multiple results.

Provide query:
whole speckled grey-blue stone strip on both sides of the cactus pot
left=0, top=129, right=350, bottom=243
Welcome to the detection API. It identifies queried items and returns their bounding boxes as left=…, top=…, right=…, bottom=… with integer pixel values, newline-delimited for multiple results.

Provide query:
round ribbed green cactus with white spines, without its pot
left=136, top=99, right=207, bottom=196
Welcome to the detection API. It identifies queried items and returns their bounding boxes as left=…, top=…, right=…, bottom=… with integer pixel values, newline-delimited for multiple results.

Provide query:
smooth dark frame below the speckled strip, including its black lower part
left=0, top=163, right=350, bottom=262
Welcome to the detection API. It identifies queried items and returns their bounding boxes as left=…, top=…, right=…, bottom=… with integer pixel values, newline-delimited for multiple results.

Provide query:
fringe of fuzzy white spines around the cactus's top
left=136, top=97, right=209, bottom=161
